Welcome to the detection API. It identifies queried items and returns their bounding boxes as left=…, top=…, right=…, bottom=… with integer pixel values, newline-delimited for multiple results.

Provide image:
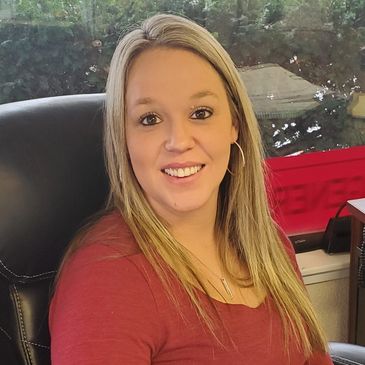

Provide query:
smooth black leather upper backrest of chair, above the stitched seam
left=0, top=94, right=108, bottom=282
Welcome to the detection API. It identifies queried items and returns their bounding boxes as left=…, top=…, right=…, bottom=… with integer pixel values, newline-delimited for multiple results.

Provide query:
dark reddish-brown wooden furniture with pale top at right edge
left=347, top=199, right=365, bottom=345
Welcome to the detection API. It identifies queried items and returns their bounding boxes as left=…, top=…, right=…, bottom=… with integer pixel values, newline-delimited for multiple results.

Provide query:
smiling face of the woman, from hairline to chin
left=126, top=48, right=237, bottom=218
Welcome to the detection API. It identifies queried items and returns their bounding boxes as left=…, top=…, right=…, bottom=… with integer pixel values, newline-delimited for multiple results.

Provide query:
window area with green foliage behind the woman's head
left=0, top=0, right=365, bottom=156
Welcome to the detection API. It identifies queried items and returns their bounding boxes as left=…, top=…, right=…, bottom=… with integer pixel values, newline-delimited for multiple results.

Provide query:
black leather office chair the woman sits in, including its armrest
left=0, top=94, right=365, bottom=365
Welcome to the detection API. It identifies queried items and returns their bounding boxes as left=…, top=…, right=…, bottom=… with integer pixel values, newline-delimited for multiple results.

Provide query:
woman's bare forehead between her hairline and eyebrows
left=126, top=48, right=226, bottom=103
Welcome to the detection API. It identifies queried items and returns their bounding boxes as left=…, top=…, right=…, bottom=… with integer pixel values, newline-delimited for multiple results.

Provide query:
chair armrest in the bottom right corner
left=329, top=342, right=365, bottom=365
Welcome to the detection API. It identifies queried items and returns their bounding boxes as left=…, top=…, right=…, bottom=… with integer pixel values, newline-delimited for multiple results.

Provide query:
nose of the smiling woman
left=165, top=119, right=195, bottom=152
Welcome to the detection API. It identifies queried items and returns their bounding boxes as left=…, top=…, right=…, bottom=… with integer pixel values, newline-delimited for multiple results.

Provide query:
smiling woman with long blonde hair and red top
left=50, top=15, right=332, bottom=365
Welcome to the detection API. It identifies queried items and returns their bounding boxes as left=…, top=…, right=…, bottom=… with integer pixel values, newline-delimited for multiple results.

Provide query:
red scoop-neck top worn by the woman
left=49, top=212, right=332, bottom=365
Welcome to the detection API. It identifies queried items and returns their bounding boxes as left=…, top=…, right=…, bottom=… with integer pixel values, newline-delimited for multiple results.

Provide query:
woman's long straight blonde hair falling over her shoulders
left=81, top=14, right=326, bottom=356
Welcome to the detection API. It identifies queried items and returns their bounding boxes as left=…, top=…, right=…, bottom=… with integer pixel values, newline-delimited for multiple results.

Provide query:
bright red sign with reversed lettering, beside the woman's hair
left=267, top=146, right=365, bottom=235
